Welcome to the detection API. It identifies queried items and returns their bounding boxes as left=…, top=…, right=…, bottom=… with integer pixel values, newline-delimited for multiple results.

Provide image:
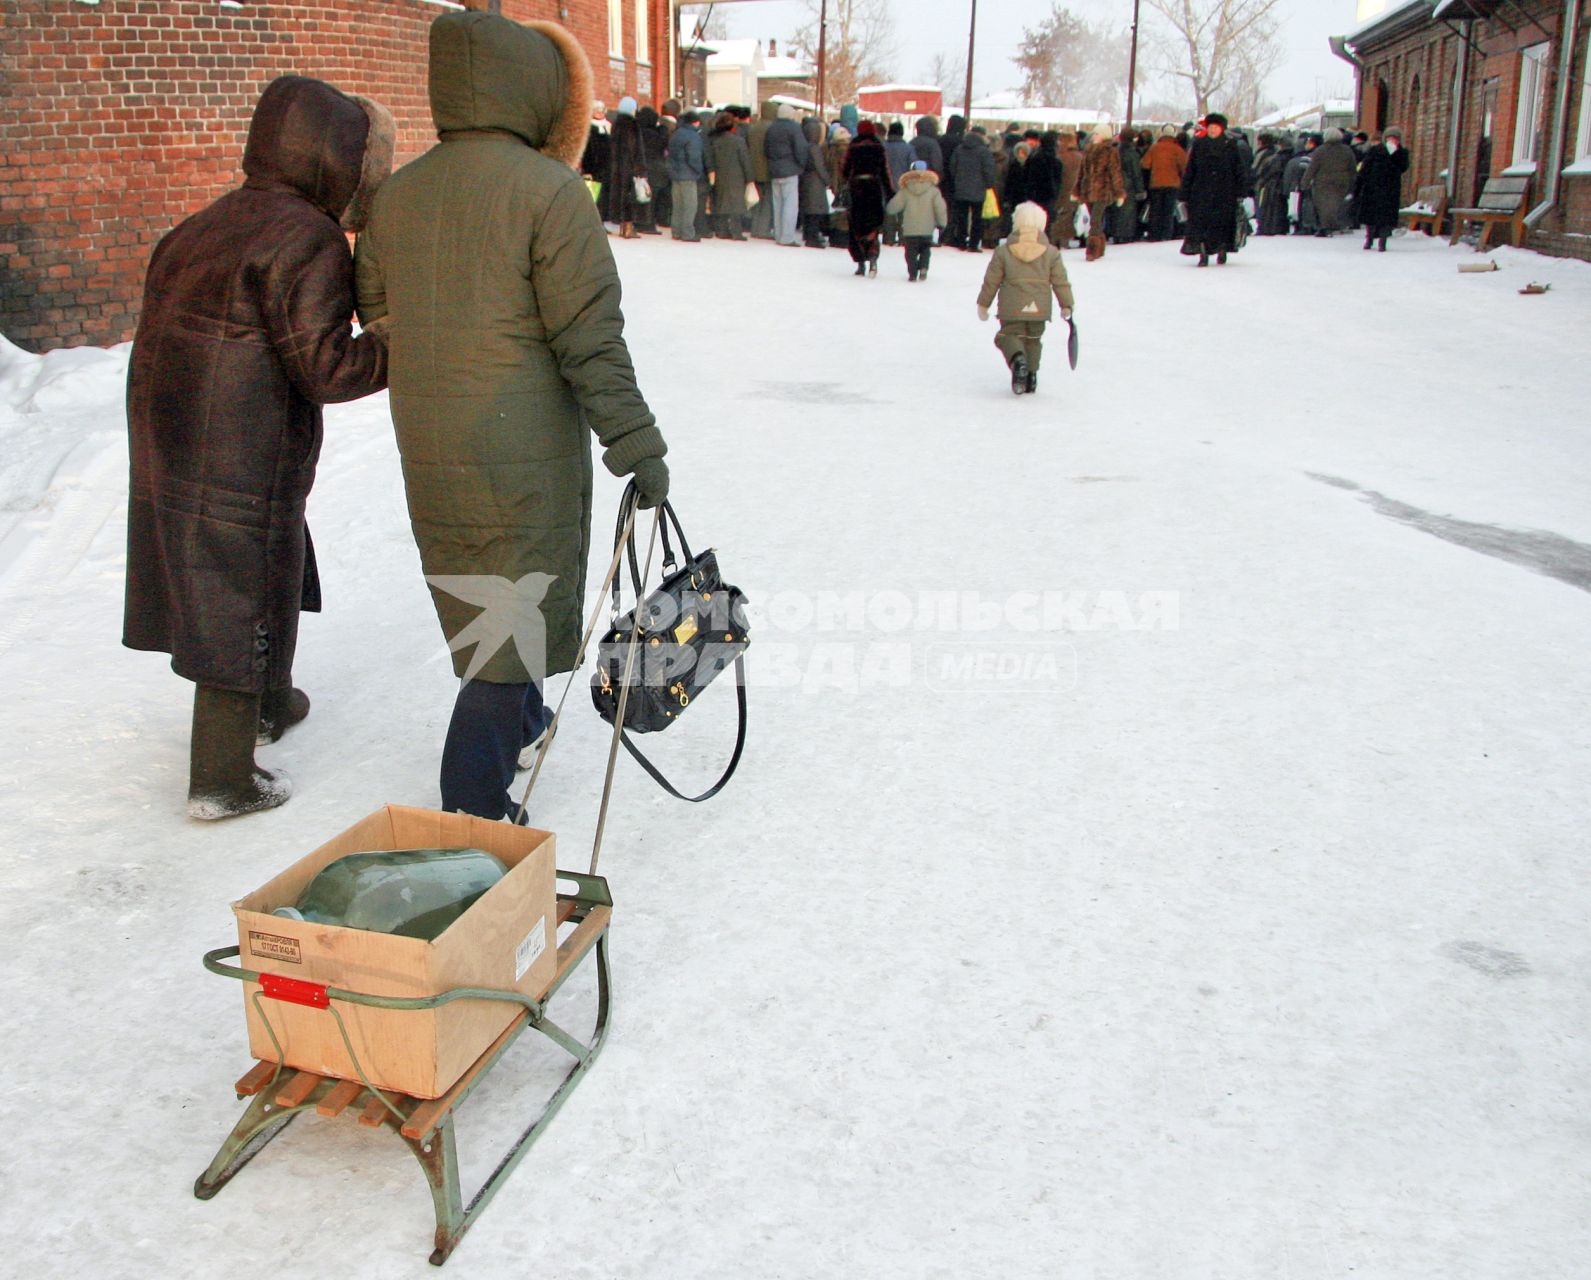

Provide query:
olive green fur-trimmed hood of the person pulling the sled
left=430, top=10, right=593, bottom=170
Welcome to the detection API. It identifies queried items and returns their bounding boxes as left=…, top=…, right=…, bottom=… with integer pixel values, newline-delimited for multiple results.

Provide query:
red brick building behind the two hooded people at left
left=0, top=0, right=678, bottom=351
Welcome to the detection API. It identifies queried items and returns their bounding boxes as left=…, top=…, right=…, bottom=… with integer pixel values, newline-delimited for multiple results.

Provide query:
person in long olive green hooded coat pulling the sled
left=356, top=11, right=668, bottom=817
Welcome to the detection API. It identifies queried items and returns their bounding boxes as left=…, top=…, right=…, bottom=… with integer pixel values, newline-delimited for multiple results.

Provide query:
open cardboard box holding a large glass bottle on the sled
left=232, top=805, right=558, bottom=1097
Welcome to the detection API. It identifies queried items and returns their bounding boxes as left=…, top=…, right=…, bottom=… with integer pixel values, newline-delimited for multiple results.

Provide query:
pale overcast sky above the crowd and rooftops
left=715, top=0, right=1356, bottom=107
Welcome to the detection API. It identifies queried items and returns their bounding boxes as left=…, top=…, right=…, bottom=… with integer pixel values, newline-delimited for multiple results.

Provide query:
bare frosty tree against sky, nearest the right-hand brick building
left=1146, top=0, right=1281, bottom=119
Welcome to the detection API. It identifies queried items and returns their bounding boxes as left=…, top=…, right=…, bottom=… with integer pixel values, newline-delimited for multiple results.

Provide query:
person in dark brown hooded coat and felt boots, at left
left=123, top=76, right=395, bottom=819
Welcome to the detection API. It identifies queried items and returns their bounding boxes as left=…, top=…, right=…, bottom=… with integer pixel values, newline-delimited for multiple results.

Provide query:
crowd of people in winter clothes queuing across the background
left=582, top=97, right=1408, bottom=271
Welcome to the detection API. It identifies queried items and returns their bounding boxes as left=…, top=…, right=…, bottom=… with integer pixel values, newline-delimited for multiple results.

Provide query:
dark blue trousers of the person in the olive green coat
left=442, top=681, right=552, bottom=817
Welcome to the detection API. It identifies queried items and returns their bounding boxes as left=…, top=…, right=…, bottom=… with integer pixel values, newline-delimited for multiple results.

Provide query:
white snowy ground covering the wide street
left=0, top=239, right=1591, bottom=1280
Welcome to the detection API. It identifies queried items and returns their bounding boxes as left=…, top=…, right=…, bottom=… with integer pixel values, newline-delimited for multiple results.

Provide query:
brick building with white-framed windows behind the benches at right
left=1333, top=0, right=1591, bottom=259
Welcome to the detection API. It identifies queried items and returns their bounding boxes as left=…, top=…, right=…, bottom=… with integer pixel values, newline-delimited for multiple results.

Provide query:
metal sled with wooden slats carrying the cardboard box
left=194, top=871, right=613, bottom=1267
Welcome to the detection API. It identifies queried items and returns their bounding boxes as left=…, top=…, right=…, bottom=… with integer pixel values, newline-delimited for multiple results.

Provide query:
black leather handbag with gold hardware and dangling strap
left=592, top=483, right=751, bottom=805
